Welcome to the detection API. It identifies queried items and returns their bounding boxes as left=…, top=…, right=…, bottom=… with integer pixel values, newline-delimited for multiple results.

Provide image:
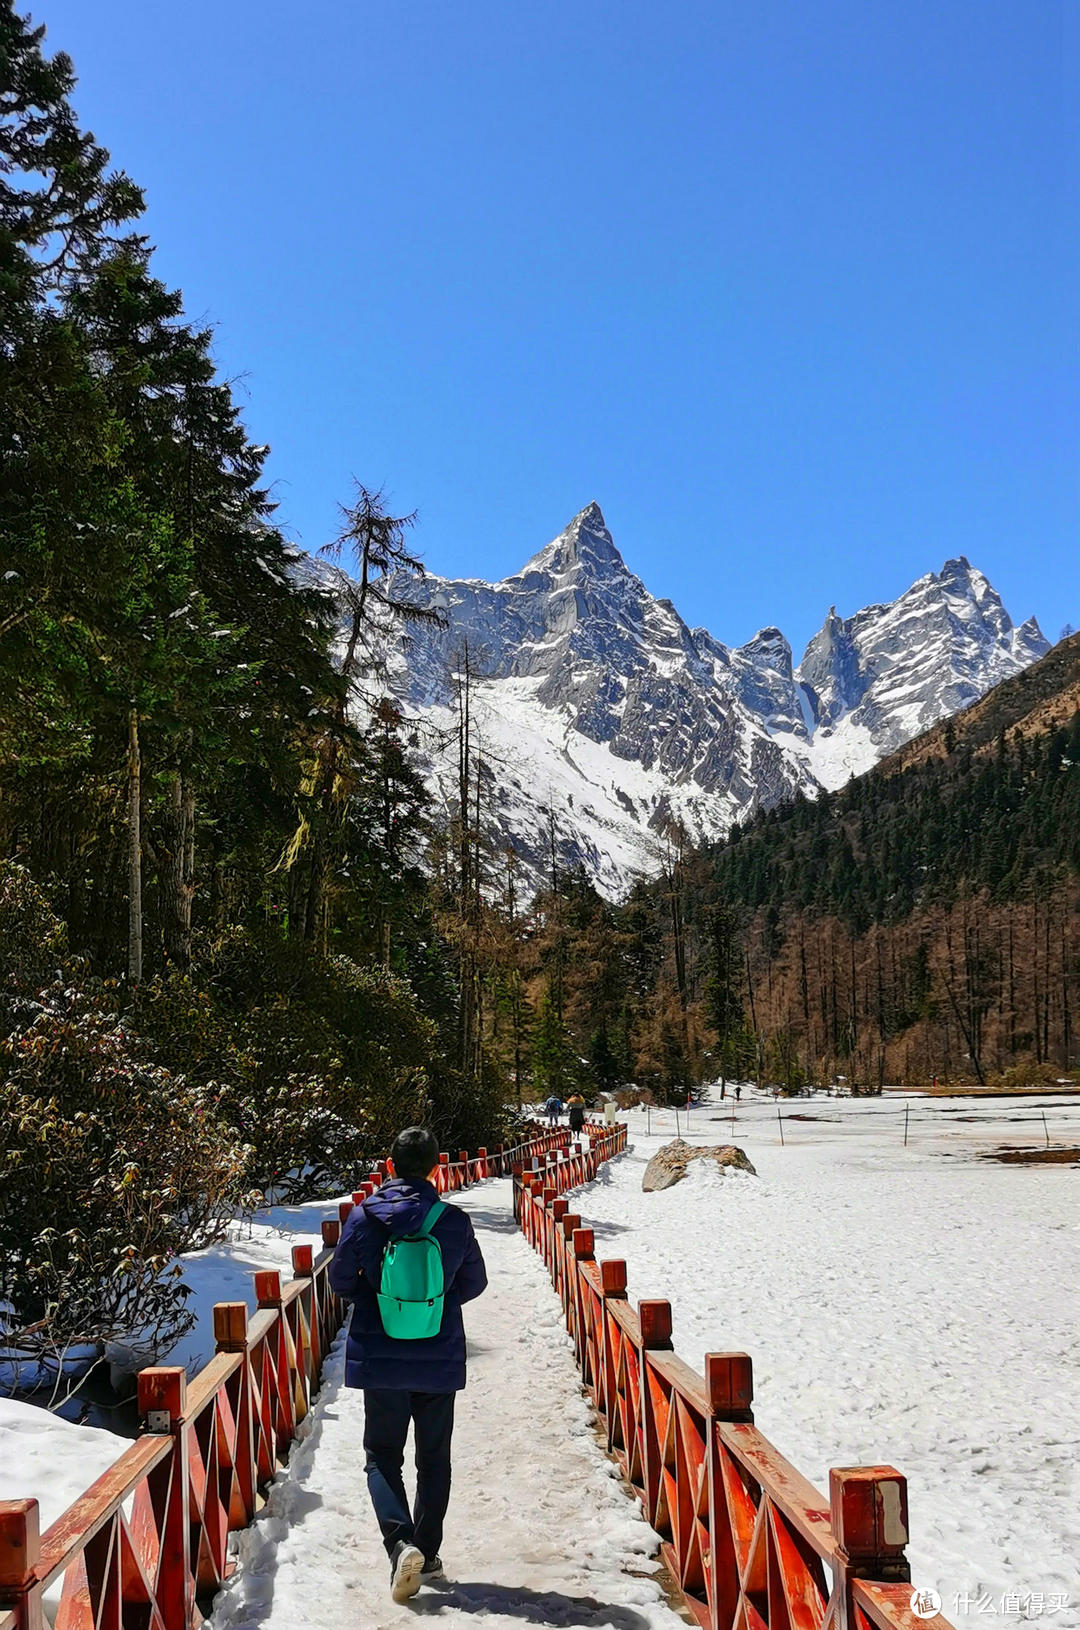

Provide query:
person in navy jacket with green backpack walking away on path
left=331, top=1126, right=487, bottom=1602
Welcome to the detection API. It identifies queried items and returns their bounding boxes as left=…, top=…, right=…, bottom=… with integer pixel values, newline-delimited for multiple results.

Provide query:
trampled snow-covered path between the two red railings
left=212, top=1182, right=679, bottom=1630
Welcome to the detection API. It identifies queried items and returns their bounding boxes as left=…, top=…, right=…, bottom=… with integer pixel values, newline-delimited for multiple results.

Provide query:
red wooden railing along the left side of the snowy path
left=0, top=1126, right=570, bottom=1630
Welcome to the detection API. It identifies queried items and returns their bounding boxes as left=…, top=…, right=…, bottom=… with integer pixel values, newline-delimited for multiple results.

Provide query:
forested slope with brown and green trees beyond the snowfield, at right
left=527, top=636, right=1080, bottom=1090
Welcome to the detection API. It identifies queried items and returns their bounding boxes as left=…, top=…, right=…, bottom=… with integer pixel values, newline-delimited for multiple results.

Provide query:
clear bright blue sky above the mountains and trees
left=38, top=0, right=1080, bottom=654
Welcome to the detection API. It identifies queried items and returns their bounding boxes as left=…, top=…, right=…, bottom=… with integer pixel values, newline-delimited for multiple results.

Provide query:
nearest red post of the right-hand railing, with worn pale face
left=829, top=1465, right=911, bottom=1630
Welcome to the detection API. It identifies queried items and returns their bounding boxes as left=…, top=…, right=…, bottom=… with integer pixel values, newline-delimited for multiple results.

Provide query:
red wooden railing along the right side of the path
left=515, top=1126, right=950, bottom=1630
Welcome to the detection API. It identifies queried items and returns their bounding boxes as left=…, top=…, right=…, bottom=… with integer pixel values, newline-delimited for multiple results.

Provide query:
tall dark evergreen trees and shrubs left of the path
left=0, top=9, right=507, bottom=1388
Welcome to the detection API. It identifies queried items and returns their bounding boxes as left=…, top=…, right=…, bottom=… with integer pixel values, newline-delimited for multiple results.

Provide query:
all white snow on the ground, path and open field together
left=0, top=1090, right=1080, bottom=1630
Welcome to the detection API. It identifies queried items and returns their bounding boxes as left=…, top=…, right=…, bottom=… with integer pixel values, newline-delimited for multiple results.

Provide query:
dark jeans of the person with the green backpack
left=363, top=1387, right=454, bottom=1560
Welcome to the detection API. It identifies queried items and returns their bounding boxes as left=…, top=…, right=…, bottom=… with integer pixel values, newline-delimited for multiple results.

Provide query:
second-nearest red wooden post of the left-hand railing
left=137, top=1364, right=195, bottom=1630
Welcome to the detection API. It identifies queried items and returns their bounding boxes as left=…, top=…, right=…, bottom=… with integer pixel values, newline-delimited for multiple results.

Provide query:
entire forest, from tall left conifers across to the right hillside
left=0, top=0, right=1080, bottom=1388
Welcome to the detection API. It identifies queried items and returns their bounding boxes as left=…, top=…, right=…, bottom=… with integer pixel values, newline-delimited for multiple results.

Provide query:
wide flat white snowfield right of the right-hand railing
left=592, top=1089, right=1080, bottom=1630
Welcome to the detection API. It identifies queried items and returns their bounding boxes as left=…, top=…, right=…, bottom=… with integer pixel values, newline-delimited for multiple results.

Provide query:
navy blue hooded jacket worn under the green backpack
left=331, top=1177, right=487, bottom=1392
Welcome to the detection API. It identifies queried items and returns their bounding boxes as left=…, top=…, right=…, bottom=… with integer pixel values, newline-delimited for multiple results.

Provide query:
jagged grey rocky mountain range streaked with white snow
left=358, top=504, right=1049, bottom=895
